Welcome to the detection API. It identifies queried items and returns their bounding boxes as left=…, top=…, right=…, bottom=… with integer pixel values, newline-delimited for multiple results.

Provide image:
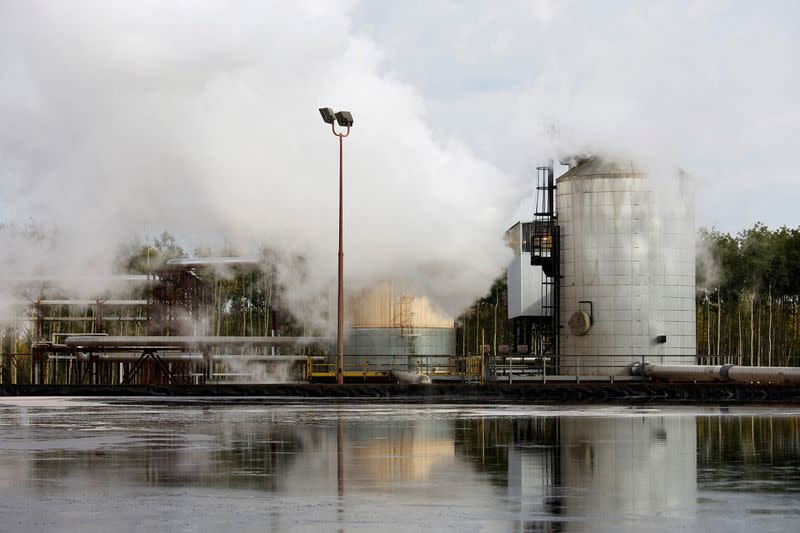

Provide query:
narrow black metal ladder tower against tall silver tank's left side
left=530, top=161, right=561, bottom=373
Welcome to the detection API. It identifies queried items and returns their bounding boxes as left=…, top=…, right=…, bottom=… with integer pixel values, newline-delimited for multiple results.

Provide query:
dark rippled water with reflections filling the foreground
left=0, top=398, right=800, bottom=533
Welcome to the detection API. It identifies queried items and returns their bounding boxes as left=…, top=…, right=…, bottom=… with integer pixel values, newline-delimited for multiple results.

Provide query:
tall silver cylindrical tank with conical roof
left=556, top=157, right=695, bottom=375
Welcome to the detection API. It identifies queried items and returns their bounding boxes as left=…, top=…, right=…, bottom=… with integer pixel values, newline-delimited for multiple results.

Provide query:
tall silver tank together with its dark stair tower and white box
left=503, top=157, right=696, bottom=378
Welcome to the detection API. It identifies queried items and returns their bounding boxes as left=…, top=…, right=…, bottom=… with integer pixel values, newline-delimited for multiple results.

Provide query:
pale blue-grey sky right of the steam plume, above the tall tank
left=356, top=0, right=800, bottom=232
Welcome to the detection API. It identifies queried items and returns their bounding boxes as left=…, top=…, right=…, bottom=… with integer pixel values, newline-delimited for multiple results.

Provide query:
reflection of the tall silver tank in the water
left=560, top=416, right=697, bottom=529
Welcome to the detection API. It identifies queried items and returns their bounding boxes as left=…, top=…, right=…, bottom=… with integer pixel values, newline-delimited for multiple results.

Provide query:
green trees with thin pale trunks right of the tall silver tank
left=697, top=223, right=800, bottom=366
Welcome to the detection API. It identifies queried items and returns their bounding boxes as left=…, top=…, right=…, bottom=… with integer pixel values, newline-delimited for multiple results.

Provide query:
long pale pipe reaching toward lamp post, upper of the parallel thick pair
left=64, top=335, right=328, bottom=349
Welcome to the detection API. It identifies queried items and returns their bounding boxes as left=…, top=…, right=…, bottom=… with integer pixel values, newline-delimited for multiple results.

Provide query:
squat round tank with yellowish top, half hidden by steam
left=345, top=281, right=455, bottom=373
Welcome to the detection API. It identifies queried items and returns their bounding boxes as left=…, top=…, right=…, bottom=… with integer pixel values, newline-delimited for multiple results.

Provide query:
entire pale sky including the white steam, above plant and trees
left=0, top=0, right=800, bottom=320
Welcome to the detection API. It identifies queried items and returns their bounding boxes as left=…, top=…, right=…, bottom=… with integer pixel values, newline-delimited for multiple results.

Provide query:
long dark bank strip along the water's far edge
left=0, top=383, right=800, bottom=405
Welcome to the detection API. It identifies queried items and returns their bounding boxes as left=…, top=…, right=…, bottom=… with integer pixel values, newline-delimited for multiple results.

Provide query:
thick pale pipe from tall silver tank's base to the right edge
left=630, top=362, right=800, bottom=383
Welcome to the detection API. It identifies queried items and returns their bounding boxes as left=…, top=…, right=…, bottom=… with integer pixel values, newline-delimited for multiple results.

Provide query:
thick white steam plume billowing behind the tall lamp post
left=0, top=1, right=515, bottom=324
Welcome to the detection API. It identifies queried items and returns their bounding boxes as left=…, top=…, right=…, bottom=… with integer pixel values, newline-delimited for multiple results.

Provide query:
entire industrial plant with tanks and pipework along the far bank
left=0, top=156, right=800, bottom=401
